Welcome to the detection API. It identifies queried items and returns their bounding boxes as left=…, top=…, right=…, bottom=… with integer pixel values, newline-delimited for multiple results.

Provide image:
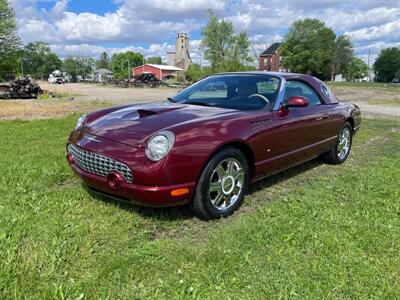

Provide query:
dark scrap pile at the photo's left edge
left=0, top=78, right=43, bottom=99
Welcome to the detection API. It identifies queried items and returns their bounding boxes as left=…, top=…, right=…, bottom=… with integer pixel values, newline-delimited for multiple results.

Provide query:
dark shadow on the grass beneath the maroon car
left=82, top=159, right=323, bottom=221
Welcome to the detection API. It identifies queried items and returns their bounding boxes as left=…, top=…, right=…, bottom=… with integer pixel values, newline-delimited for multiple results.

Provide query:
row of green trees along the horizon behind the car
left=0, top=0, right=400, bottom=82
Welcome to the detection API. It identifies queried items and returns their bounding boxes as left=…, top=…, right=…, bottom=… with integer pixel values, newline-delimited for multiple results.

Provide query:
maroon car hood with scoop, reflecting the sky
left=83, top=102, right=238, bottom=147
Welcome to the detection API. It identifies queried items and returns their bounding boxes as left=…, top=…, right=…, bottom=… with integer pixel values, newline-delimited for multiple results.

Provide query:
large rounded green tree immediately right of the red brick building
left=280, top=19, right=335, bottom=80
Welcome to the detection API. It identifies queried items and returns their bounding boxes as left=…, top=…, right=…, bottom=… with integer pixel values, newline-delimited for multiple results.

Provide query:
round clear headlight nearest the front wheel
left=146, top=131, right=175, bottom=161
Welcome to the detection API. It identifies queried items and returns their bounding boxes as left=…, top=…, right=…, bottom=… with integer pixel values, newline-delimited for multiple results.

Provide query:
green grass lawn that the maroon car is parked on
left=0, top=116, right=400, bottom=299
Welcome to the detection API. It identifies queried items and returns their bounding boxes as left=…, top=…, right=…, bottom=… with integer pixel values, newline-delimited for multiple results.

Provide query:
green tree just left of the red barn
left=111, top=51, right=144, bottom=79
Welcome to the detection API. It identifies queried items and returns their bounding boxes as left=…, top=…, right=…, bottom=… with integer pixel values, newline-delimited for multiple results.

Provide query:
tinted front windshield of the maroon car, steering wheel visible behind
left=173, top=74, right=280, bottom=110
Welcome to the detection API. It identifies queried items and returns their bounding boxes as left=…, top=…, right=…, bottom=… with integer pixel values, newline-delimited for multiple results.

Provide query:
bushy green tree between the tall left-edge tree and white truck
left=21, top=42, right=62, bottom=79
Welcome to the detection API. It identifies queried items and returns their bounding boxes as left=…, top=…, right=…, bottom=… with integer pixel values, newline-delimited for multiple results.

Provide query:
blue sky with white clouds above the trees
left=9, top=0, right=400, bottom=63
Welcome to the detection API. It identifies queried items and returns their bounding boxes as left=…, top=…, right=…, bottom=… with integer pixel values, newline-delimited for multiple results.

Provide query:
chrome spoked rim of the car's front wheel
left=208, top=158, right=244, bottom=211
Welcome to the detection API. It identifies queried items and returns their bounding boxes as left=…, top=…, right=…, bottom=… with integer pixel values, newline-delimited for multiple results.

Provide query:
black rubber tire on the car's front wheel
left=191, top=147, right=249, bottom=219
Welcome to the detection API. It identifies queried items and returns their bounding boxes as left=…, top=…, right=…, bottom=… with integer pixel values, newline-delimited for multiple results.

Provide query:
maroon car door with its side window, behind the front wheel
left=258, top=80, right=334, bottom=178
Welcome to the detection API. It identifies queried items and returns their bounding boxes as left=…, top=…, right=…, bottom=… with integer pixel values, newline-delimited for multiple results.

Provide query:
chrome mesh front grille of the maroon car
left=67, top=144, right=133, bottom=183
